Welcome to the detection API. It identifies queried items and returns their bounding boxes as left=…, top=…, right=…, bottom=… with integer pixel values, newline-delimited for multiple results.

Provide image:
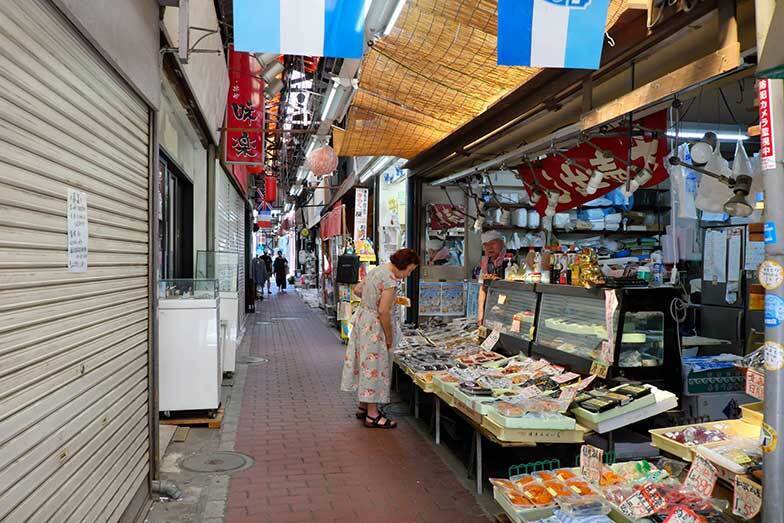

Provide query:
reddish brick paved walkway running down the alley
left=226, top=292, right=489, bottom=523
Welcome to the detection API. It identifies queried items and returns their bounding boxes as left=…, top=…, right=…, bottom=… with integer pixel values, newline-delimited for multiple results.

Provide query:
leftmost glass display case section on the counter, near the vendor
left=485, top=281, right=538, bottom=354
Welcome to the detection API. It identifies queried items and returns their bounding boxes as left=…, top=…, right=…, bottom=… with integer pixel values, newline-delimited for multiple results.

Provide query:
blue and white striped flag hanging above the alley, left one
left=234, top=0, right=371, bottom=58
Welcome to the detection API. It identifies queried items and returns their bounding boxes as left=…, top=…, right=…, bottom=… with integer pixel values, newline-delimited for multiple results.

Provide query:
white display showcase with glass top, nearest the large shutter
left=158, top=279, right=223, bottom=415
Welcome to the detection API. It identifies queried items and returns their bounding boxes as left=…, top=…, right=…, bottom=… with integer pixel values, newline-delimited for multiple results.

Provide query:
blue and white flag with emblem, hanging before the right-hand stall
left=498, top=0, right=610, bottom=69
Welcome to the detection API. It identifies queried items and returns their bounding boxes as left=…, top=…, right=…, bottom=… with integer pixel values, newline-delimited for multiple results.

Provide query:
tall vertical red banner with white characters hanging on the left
left=223, top=47, right=264, bottom=189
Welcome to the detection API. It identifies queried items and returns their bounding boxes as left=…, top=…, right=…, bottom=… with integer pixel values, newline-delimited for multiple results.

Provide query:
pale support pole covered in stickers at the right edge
left=754, top=0, right=784, bottom=522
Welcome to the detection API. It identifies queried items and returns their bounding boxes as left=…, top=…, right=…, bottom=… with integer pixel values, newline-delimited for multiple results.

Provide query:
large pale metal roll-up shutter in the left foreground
left=0, top=0, right=150, bottom=522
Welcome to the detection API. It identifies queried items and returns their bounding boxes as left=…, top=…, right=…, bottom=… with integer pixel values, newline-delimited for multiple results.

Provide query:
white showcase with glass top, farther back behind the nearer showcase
left=196, top=251, right=242, bottom=373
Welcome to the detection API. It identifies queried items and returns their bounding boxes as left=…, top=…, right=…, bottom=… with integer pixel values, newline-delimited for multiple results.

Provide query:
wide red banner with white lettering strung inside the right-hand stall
left=518, top=111, right=668, bottom=214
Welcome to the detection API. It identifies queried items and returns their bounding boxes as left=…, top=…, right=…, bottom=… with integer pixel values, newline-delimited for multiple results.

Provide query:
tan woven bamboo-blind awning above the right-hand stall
left=336, top=0, right=627, bottom=158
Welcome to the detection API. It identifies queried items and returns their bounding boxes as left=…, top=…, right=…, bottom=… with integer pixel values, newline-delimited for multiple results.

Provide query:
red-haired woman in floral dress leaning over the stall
left=340, top=249, right=419, bottom=429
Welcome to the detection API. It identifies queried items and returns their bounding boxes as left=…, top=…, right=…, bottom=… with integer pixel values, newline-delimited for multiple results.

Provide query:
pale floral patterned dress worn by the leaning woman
left=340, top=266, right=401, bottom=403
